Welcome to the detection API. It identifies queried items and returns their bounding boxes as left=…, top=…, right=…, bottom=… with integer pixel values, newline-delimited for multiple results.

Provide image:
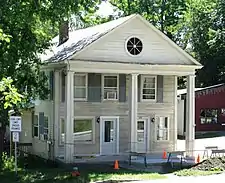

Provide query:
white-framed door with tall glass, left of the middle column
left=100, top=116, right=119, bottom=155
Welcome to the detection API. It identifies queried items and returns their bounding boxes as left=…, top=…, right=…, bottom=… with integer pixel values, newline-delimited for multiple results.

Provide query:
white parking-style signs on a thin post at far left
left=10, top=116, right=22, bottom=175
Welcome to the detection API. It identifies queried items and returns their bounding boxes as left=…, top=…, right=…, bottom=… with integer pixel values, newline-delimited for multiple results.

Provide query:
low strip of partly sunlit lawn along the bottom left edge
left=0, top=168, right=166, bottom=183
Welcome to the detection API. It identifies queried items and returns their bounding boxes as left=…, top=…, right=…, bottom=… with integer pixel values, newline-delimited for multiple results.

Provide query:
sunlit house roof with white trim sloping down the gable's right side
left=41, top=14, right=201, bottom=67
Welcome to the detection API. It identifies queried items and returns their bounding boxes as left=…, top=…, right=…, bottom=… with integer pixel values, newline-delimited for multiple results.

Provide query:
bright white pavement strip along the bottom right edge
left=129, top=173, right=225, bottom=183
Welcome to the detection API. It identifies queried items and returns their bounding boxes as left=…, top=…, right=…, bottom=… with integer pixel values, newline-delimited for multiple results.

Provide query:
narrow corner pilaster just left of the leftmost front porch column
left=53, top=71, right=60, bottom=157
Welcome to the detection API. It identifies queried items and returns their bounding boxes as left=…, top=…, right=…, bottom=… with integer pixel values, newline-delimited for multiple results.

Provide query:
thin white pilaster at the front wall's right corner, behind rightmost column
left=173, top=76, right=178, bottom=151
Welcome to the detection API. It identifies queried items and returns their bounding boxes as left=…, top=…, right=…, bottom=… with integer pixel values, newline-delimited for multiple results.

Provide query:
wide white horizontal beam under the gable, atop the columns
left=70, top=60, right=200, bottom=76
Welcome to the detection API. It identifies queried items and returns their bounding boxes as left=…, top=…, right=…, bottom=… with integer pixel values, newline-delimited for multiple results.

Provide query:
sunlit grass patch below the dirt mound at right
left=174, top=169, right=223, bottom=176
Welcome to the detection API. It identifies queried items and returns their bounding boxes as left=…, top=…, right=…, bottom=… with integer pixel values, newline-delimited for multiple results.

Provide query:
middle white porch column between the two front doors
left=129, top=74, right=138, bottom=152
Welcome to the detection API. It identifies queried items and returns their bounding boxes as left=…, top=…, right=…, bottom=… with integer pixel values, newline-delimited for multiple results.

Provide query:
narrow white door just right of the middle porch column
left=137, top=118, right=149, bottom=153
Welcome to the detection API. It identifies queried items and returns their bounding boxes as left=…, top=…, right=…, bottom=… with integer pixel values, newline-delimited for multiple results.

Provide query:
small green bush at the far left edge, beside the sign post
left=1, top=153, right=15, bottom=171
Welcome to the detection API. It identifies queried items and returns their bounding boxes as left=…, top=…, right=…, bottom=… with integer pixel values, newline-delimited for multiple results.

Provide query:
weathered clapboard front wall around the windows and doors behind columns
left=56, top=76, right=175, bottom=155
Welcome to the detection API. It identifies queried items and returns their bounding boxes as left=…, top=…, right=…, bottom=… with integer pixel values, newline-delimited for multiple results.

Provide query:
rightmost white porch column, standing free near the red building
left=185, top=75, right=195, bottom=156
